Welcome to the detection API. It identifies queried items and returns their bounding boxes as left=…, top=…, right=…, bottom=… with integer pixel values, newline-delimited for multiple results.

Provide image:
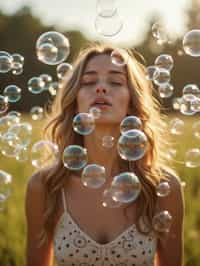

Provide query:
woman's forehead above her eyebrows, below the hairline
left=84, top=54, right=126, bottom=75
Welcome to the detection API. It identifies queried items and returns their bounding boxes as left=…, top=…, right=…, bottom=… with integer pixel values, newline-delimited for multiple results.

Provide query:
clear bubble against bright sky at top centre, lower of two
left=95, top=12, right=123, bottom=37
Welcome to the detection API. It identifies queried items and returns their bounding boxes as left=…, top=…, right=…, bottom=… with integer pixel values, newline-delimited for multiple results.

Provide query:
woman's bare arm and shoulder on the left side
left=25, top=174, right=53, bottom=266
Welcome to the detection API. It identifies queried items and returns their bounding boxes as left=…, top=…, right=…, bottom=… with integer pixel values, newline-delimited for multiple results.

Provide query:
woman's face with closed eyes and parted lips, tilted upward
left=77, top=54, right=130, bottom=124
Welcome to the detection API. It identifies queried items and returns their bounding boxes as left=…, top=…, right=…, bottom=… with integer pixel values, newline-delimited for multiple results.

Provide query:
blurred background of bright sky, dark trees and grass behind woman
left=0, top=0, right=200, bottom=266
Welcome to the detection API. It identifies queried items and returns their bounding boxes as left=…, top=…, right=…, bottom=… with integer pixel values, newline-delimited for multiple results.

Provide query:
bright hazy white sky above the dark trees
left=0, top=0, right=190, bottom=45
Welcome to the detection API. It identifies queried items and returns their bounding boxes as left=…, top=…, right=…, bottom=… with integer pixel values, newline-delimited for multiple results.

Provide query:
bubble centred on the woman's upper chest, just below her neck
left=81, top=164, right=106, bottom=188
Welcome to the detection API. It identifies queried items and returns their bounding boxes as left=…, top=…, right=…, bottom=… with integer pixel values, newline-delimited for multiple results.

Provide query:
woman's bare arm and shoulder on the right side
left=155, top=172, right=184, bottom=266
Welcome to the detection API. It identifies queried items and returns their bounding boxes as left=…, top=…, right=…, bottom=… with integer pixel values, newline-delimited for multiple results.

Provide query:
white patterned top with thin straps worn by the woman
left=54, top=189, right=157, bottom=266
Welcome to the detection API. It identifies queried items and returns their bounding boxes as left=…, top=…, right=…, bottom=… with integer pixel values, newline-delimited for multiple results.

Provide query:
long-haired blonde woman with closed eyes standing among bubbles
left=26, top=44, right=184, bottom=266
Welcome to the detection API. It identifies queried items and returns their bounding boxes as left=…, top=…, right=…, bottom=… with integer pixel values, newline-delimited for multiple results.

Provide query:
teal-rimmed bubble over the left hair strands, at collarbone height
left=63, top=145, right=88, bottom=171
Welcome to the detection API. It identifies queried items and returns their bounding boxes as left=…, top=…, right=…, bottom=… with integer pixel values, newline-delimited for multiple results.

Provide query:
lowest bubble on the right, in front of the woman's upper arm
left=152, top=210, right=172, bottom=233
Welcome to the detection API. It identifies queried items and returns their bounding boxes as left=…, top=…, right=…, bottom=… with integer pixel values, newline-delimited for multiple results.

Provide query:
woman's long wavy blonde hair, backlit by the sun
left=39, top=43, right=172, bottom=245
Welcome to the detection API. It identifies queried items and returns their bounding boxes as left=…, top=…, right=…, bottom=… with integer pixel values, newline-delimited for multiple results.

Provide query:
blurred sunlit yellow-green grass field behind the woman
left=0, top=113, right=200, bottom=266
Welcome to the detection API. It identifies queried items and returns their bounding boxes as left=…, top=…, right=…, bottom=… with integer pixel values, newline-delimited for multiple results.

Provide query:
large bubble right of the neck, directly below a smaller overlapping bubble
left=117, top=129, right=148, bottom=161
